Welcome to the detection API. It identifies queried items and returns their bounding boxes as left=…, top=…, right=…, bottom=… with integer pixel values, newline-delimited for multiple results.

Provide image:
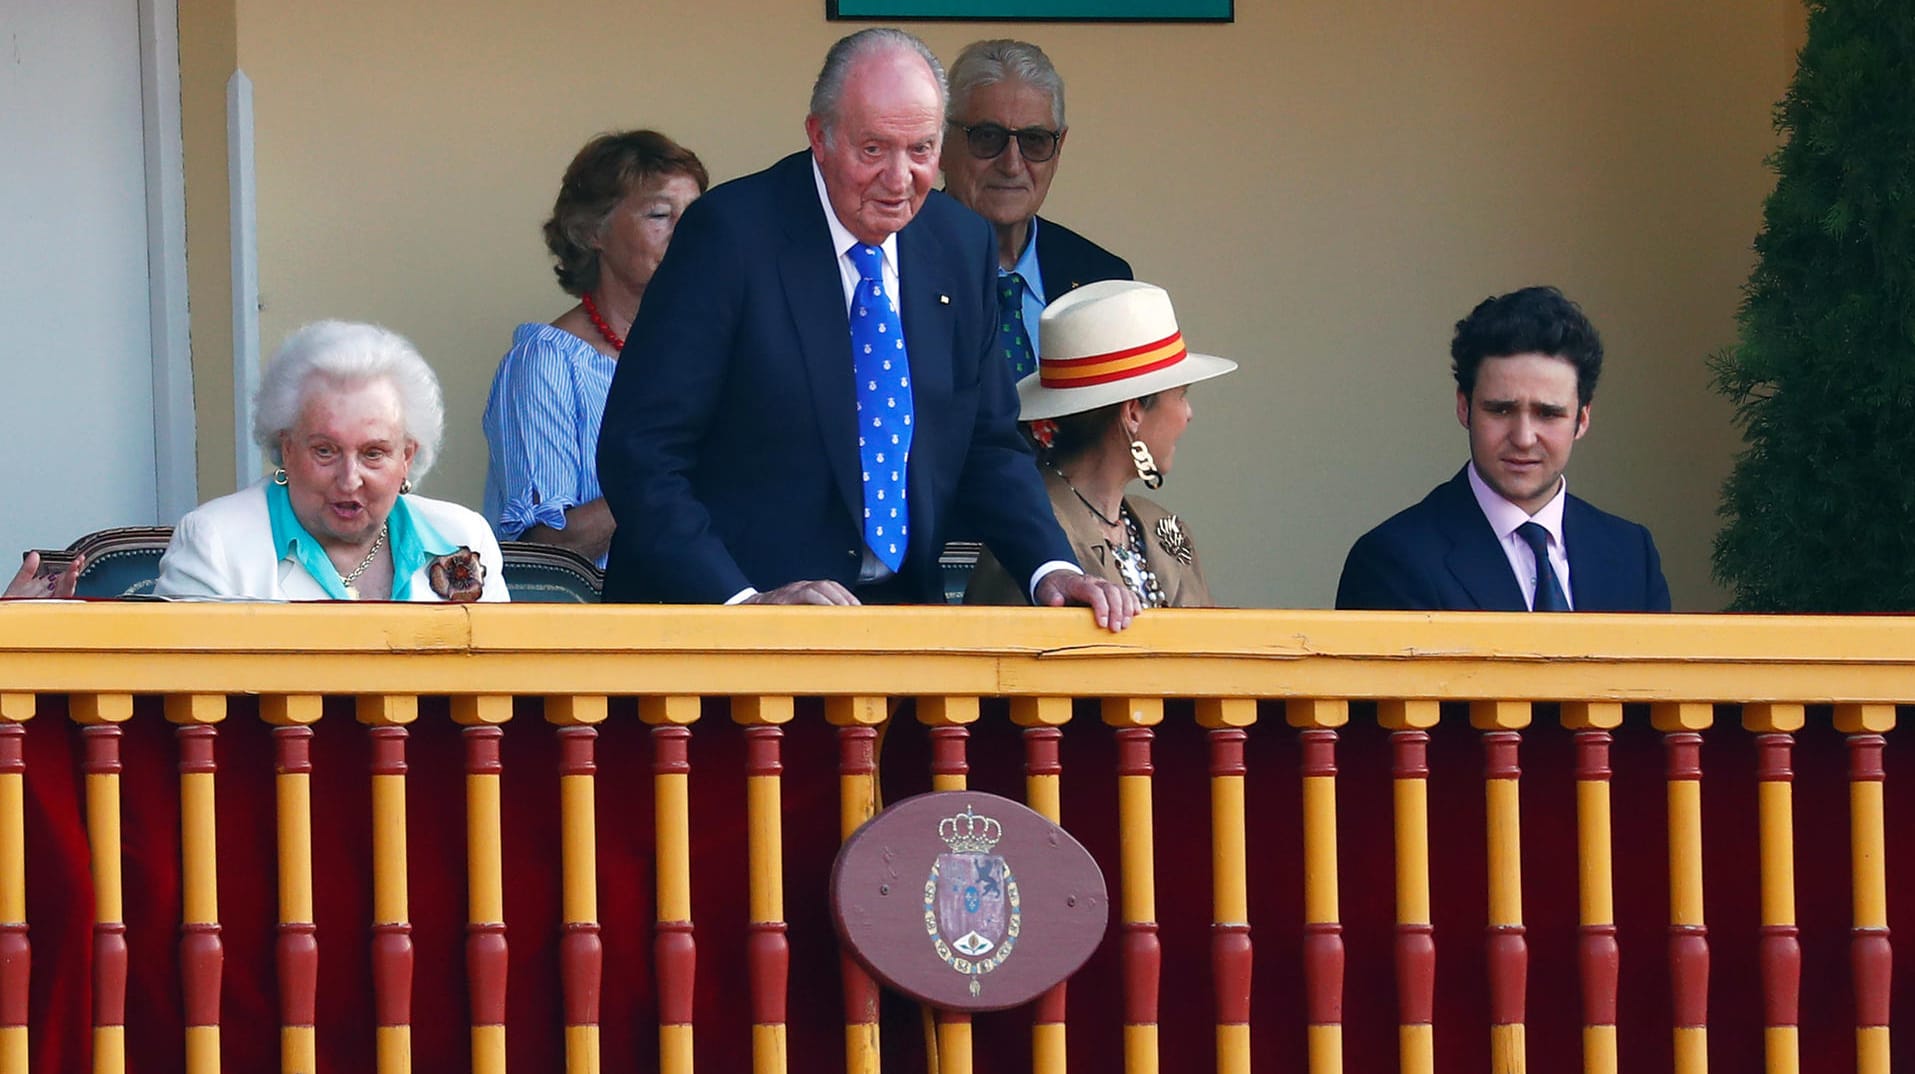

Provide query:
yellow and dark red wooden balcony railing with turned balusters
left=0, top=603, right=1915, bottom=1074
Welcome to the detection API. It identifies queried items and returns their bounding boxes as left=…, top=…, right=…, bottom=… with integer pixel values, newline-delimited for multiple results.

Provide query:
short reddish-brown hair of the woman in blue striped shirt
left=546, top=130, right=710, bottom=295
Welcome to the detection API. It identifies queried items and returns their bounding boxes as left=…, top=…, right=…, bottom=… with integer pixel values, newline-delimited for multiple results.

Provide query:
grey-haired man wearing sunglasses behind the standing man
left=940, top=40, right=1132, bottom=377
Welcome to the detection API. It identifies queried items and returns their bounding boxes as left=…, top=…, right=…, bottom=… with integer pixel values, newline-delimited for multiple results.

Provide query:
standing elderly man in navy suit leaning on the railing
left=597, top=29, right=1138, bottom=630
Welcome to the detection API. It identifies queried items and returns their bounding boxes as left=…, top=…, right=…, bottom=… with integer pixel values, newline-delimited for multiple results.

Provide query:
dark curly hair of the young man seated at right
left=1450, top=287, right=1603, bottom=406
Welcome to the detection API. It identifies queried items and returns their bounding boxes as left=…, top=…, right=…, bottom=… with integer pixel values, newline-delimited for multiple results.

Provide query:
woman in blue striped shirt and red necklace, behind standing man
left=484, top=130, right=710, bottom=567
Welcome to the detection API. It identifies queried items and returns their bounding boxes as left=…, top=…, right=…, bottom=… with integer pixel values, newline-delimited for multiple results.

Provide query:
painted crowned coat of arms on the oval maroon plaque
left=925, top=804, right=1023, bottom=997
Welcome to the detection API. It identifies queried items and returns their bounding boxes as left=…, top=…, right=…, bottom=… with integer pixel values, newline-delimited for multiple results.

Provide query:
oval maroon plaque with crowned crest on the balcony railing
left=831, top=791, right=1111, bottom=1011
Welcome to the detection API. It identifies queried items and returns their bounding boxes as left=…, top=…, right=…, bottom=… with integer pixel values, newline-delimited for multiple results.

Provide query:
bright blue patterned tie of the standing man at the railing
left=850, top=243, right=912, bottom=571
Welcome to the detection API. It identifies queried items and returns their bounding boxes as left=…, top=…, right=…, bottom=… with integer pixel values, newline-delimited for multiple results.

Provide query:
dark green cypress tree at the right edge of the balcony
left=1710, top=0, right=1915, bottom=613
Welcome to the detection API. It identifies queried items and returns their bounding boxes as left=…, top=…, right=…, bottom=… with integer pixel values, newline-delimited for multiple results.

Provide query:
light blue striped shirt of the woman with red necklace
left=484, top=324, right=619, bottom=567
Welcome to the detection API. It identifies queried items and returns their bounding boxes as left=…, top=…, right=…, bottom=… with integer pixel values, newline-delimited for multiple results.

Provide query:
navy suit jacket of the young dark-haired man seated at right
left=1337, top=465, right=1670, bottom=611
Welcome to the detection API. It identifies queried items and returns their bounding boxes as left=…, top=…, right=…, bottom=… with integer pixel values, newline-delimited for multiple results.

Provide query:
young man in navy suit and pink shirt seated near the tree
left=1337, top=287, right=1670, bottom=611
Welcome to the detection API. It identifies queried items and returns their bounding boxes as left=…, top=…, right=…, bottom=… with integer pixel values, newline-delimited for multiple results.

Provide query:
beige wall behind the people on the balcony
left=188, top=0, right=1800, bottom=609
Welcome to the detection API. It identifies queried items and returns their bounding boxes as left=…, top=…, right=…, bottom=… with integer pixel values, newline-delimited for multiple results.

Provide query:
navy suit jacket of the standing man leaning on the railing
left=597, top=151, right=1072, bottom=603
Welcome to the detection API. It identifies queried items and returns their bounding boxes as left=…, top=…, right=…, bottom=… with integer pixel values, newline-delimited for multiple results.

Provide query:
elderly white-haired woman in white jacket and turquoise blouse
left=153, top=322, right=507, bottom=601
